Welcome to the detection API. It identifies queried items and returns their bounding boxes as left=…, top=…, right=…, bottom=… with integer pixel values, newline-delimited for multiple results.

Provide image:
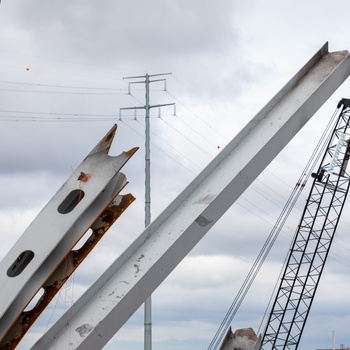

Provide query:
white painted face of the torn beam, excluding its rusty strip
left=0, top=125, right=137, bottom=339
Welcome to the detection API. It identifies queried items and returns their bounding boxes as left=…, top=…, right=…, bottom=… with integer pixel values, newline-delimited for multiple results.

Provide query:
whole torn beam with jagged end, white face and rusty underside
left=0, top=125, right=138, bottom=349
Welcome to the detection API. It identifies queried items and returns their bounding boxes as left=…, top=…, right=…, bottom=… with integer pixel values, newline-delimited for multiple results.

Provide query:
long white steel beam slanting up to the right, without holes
left=32, top=43, right=350, bottom=350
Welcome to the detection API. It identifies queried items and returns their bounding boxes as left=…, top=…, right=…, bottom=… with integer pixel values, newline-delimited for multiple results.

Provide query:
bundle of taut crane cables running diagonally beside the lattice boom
left=207, top=104, right=339, bottom=350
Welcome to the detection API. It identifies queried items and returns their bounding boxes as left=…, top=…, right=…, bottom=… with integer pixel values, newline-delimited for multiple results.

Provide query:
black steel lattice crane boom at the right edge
left=261, top=99, right=350, bottom=350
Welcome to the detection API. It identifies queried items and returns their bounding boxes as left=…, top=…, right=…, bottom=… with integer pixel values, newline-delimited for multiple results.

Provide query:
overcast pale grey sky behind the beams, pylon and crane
left=0, top=0, right=350, bottom=350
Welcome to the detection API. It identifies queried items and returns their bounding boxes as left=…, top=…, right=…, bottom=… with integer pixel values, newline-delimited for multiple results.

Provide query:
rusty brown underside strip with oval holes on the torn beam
left=0, top=194, right=135, bottom=350
